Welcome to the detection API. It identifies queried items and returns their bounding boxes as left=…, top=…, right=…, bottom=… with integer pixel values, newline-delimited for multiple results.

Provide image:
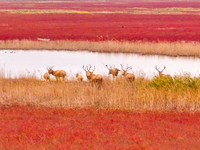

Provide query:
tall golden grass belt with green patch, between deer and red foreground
left=0, top=75, right=200, bottom=112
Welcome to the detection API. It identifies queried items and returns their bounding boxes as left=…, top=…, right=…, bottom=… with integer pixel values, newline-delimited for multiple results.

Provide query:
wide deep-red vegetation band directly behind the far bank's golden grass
left=0, top=13, right=200, bottom=41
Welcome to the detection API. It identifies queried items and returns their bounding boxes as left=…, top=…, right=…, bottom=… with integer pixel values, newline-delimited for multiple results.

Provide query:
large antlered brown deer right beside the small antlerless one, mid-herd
left=83, top=65, right=103, bottom=84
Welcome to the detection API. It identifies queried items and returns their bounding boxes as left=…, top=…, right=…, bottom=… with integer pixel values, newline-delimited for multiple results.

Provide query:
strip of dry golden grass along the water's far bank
left=0, top=39, right=200, bottom=57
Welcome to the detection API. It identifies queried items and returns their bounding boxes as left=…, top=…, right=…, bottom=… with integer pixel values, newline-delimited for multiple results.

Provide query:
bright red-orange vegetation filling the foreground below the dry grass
left=0, top=106, right=200, bottom=149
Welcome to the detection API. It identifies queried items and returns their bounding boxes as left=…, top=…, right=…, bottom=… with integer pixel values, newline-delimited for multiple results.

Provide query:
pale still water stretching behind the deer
left=0, top=50, right=200, bottom=79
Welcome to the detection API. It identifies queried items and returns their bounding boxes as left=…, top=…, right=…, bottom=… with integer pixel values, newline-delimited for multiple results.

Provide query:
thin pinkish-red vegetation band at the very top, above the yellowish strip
left=0, top=0, right=200, bottom=11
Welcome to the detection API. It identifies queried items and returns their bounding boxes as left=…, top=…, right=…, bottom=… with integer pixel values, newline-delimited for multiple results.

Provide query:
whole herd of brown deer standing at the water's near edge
left=43, top=64, right=172, bottom=84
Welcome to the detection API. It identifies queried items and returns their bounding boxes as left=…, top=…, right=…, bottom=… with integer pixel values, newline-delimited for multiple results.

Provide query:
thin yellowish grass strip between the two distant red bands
left=0, top=7, right=200, bottom=15
